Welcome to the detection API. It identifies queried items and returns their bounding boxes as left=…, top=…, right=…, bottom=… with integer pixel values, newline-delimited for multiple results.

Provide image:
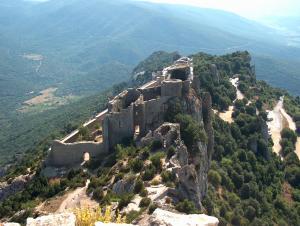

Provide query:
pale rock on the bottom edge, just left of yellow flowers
left=26, top=213, right=76, bottom=226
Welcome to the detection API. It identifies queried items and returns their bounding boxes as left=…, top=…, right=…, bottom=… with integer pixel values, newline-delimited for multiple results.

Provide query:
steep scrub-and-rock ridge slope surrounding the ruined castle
left=0, top=52, right=300, bottom=226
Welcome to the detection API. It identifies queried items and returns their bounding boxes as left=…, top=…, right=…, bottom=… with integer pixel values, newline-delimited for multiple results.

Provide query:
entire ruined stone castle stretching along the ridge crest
left=46, top=57, right=197, bottom=167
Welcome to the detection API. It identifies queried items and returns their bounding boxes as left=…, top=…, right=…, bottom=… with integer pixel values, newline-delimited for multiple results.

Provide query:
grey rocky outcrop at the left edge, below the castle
left=0, top=175, right=31, bottom=201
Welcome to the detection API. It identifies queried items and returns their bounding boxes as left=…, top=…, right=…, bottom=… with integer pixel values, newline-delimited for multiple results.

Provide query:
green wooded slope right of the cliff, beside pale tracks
left=192, top=52, right=300, bottom=225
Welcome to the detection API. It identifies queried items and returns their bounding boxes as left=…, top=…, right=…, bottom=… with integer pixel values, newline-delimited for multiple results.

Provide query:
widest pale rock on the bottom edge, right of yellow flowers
left=149, top=209, right=219, bottom=226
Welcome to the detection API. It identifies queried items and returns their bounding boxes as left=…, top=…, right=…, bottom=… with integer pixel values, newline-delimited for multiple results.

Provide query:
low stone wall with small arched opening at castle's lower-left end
left=46, top=140, right=106, bottom=167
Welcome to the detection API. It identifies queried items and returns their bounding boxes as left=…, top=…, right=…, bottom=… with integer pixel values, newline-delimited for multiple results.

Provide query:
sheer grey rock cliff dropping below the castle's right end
left=171, top=90, right=214, bottom=208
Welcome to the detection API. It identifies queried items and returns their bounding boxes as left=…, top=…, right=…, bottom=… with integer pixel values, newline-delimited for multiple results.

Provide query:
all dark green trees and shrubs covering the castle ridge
left=0, top=52, right=300, bottom=226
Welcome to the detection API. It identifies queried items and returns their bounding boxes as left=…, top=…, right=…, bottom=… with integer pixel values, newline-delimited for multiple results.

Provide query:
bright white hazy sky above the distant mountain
left=139, top=0, right=300, bottom=19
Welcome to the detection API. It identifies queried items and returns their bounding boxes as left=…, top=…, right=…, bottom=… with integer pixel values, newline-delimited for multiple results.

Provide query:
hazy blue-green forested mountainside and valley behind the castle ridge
left=0, top=0, right=300, bottom=167
